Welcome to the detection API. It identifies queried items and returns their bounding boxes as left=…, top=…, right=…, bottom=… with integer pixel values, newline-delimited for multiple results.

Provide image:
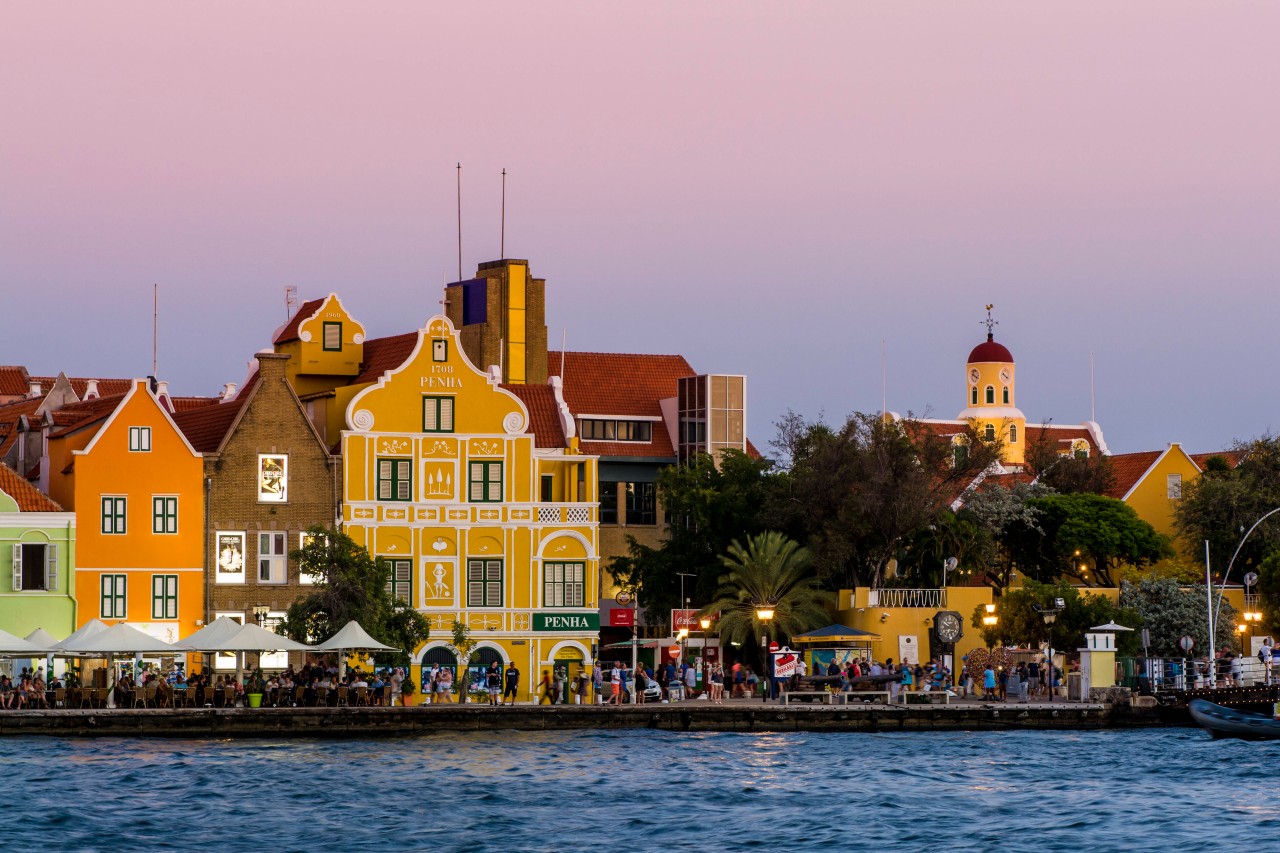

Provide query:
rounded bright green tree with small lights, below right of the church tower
left=1004, top=493, right=1174, bottom=587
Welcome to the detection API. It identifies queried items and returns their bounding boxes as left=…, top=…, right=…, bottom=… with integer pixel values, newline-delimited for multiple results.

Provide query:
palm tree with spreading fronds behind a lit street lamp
left=703, top=530, right=833, bottom=646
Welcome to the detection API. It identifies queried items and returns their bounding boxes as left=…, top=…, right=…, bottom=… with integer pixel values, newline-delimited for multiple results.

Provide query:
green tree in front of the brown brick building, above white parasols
left=279, top=526, right=431, bottom=666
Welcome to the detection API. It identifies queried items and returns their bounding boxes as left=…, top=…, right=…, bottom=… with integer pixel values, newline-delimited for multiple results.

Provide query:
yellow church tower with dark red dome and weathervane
left=959, top=305, right=1027, bottom=465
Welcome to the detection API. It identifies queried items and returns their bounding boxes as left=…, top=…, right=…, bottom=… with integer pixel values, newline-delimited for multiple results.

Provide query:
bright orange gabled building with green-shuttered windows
left=57, top=379, right=205, bottom=643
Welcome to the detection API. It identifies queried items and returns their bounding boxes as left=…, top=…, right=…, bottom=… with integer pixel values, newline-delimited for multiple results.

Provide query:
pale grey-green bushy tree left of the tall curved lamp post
left=1120, top=578, right=1235, bottom=657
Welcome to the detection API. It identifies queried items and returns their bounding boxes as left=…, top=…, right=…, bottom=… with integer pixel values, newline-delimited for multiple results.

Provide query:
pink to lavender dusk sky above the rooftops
left=0, top=0, right=1280, bottom=452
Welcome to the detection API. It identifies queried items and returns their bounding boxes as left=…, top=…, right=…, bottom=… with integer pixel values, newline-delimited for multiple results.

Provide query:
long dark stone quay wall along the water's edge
left=0, top=703, right=1189, bottom=738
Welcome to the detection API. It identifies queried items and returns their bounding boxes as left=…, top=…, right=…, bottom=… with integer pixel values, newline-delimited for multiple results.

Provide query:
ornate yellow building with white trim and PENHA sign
left=333, top=316, right=599, bottom=701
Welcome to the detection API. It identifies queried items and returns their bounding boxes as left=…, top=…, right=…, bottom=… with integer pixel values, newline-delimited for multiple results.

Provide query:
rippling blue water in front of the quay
left=10, top=729, right=1280, bottom=853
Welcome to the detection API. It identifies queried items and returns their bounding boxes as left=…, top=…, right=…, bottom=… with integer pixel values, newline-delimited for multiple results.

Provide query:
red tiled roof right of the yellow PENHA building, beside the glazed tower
left=547, top=352, right=698, bottom=459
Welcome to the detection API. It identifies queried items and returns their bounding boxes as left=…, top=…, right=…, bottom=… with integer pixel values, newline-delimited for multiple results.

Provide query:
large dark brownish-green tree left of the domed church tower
left=777, top=412, right=1001, bottom=587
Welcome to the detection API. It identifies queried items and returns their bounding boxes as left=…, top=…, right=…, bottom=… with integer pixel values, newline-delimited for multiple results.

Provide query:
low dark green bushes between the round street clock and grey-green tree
left=972, top=580, right=1142, bottom=653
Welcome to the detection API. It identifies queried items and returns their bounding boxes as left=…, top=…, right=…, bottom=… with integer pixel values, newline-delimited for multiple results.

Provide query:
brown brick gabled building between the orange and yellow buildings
left=174, top=352, right=342, bottom=666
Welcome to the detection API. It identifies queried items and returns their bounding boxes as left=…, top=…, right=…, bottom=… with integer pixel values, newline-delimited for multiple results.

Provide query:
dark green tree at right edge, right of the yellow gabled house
left=1174, top=435, right=1280, bottom=581
